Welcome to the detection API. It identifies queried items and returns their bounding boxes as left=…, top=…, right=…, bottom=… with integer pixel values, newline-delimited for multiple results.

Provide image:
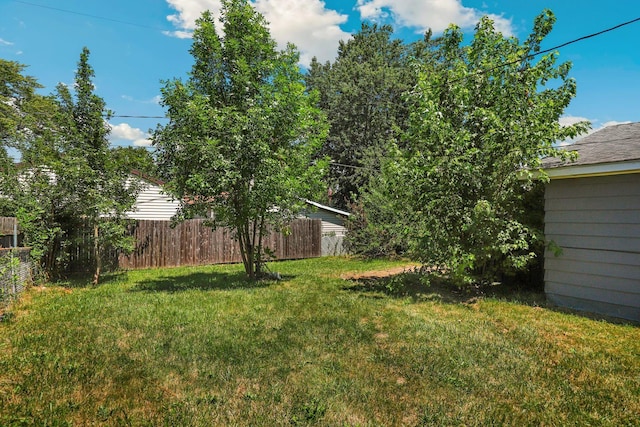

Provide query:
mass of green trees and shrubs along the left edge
left=0, top=48, right=140, bottom=283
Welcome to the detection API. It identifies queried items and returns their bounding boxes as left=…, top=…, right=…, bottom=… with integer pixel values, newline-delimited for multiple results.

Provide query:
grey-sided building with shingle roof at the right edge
left=543, top=123, right=640, bottom=322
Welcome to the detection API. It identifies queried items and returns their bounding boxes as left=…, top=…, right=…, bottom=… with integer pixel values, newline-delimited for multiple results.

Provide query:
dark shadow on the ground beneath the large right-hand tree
left=343, top=273, right=547, bottom=307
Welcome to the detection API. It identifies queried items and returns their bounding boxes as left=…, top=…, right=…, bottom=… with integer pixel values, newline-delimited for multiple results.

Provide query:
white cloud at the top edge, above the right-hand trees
left=356, top=0, right=513, bottom=36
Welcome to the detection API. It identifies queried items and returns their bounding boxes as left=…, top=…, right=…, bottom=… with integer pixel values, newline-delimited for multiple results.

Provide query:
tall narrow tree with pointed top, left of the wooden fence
left=56, top=47, right=144, bottom=284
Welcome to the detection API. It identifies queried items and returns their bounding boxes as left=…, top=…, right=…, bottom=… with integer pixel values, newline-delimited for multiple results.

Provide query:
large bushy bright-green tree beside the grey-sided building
left=358, top=10, right=588, bottom=283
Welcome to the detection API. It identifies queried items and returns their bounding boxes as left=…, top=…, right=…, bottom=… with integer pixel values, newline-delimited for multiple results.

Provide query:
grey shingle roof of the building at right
left=542, top=122, right=640, bottom=169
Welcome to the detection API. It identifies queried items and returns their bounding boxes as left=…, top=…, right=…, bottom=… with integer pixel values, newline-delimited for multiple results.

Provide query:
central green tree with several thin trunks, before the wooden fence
left=153, top=0, right=326, bottom=278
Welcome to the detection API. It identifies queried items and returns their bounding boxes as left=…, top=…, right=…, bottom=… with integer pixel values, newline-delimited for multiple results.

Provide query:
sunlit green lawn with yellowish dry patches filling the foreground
left=0, top=258, right=640, bottom=426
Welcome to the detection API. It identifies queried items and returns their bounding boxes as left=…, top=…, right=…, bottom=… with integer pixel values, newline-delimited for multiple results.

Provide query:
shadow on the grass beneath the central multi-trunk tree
left=132, top=272, right=274, bottom=293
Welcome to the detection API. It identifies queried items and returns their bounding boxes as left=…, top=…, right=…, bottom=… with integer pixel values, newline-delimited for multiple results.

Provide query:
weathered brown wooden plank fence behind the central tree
left=70, top=218, right=322, bottom=271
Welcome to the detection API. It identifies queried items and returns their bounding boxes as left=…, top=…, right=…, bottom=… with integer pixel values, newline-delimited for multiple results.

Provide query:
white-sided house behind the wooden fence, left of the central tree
left=126, top=171, right=180, bottom=221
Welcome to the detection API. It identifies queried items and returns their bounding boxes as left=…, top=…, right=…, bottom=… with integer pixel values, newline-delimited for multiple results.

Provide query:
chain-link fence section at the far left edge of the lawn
left=0, top=248, right=33, bottom=305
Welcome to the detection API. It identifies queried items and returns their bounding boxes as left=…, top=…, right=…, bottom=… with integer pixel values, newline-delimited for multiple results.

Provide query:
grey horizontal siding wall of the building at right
left=545, top=174, right=640, bottom=321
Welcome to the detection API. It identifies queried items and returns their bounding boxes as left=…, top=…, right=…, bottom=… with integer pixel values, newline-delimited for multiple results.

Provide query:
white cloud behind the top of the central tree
left=165, top=0, right=350, bottom=65
